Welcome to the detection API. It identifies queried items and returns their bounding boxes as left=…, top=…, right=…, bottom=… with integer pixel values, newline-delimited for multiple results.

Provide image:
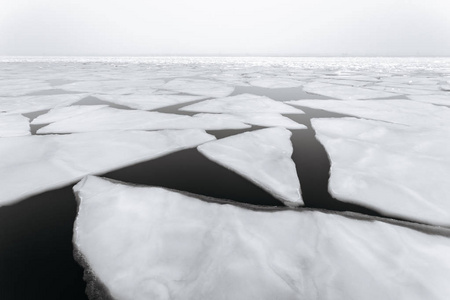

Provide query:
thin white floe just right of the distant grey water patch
left=303, top=82, right=397, bottom=100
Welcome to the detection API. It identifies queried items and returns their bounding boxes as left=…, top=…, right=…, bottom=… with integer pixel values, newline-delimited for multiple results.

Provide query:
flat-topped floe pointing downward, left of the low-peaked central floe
left=97, top=94, right=205, bottom=110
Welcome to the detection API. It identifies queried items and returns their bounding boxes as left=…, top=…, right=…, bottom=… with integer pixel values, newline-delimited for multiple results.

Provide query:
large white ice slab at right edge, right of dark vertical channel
left=312, top=118, right=450, bottom=226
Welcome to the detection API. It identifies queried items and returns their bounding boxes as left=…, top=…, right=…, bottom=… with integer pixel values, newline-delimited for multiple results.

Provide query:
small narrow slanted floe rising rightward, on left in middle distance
left=31, top=105, right=108, bottom=125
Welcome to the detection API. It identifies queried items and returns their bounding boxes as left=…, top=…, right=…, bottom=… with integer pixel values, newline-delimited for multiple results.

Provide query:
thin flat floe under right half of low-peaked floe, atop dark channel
left=233, top=113, right=307, bottom=129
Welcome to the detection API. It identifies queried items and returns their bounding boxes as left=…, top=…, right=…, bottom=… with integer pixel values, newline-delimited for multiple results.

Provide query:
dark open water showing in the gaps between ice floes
left=0, top=87, right=432, bottom=300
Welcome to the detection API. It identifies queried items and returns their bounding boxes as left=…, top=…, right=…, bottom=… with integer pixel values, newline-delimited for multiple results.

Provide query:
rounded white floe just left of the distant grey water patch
left=161, top=78, right=234, bottom=97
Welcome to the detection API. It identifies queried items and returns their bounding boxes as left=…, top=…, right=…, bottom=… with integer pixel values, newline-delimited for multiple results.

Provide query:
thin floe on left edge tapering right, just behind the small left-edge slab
left=0, top=94, right=88, bottom=113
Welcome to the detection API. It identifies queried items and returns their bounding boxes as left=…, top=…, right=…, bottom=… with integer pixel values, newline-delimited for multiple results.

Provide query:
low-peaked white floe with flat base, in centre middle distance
left=180, top=94, right=304, bottom=114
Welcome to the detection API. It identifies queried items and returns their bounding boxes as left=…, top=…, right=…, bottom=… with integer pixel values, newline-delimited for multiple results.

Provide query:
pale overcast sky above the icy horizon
left=0, top=0, right=450, bottom=56
